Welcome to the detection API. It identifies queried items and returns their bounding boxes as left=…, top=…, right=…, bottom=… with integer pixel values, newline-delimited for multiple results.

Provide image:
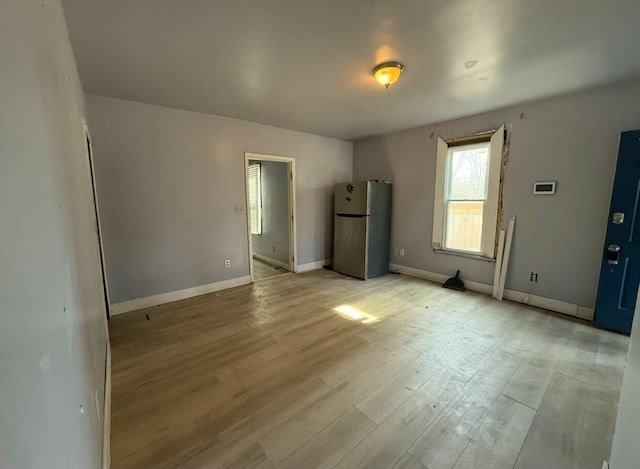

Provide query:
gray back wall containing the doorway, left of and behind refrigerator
left=86, top=95, right=353, bottom=303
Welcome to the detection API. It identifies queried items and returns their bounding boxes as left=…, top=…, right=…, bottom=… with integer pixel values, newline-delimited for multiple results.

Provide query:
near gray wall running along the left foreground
left=0, top=0, right=107, bottom=469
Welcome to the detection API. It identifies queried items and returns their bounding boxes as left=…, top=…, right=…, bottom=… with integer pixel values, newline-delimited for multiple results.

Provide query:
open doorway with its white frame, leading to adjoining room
left=245, top=153, right=297, bottom=281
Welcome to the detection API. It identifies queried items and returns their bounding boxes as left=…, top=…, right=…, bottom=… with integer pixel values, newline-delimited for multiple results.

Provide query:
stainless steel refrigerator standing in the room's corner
left=333, top=181, right=391, bottom=280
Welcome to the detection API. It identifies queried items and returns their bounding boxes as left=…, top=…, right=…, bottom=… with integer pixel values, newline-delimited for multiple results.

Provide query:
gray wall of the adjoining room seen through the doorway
left=251, top=161, right=289, bottom=264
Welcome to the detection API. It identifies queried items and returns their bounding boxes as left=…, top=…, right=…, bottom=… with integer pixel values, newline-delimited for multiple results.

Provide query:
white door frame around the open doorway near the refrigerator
left=244, top=152, right=298, bottom=282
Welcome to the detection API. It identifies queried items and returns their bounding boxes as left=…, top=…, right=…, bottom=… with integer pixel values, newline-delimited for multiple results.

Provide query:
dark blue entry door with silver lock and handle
left=594, top=130, right=640, bottom=335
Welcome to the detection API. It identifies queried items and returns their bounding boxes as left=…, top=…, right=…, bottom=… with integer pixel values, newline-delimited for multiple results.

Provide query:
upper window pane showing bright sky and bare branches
left=448, top=146, right=489, bottom=200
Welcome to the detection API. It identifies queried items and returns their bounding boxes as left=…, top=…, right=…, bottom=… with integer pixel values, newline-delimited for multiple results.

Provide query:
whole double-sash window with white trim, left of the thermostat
left=432, top=127, right=504, bottom=258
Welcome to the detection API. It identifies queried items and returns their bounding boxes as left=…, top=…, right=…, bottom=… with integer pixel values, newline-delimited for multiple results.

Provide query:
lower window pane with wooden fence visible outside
left=445, top=202, right=484, bottom=252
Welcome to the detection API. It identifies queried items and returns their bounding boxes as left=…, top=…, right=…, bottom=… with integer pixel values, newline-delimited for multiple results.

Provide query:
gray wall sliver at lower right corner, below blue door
left=610, top=297, right=640, bottom=469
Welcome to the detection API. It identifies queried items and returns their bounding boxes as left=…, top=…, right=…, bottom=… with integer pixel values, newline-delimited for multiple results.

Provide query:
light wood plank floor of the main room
left=109, top=270, right=628, bottom=469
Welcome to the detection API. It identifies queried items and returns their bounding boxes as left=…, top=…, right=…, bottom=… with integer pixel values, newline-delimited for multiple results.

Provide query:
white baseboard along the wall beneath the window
left=389, top=264, right=593, bottom=321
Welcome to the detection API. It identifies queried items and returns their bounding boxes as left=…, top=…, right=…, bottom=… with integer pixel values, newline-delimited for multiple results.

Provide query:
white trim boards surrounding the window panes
left=431, top=126, right=504, bottom=259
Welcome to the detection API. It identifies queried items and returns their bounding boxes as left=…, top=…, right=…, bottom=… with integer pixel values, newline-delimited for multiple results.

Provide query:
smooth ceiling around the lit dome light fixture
left=63, top=0, right=640, bottom=139
